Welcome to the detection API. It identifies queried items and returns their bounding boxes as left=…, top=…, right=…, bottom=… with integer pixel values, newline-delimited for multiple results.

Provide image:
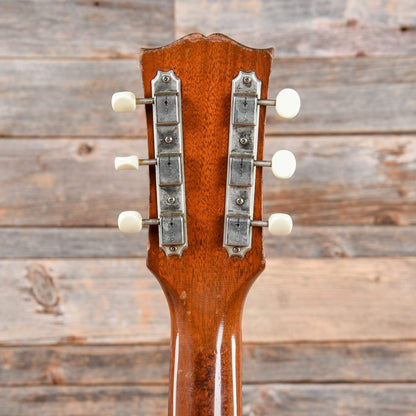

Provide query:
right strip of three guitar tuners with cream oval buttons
left=223, top=71, right=300, bottom=257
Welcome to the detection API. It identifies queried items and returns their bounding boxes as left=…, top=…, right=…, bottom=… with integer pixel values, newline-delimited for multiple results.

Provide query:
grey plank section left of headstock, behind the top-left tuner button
left=0, top=59, right=146, bottom=137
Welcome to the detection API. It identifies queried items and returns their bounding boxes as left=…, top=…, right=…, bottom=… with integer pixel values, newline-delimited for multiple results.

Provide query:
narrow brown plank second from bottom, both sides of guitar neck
left=0, top=342, right=416, bottom=387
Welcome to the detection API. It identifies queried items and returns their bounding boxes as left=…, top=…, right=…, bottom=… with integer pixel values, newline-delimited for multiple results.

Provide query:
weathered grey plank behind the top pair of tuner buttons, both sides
left=0, top=56, right=416, bottom=137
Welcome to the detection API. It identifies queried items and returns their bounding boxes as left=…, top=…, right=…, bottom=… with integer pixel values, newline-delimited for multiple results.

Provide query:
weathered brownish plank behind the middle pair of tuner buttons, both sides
left=0, top=135, right=416, bottom=226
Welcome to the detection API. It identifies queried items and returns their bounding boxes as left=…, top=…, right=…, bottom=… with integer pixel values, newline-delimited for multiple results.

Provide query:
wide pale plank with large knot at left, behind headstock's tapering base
left=0, top=258, right=416, bottom=345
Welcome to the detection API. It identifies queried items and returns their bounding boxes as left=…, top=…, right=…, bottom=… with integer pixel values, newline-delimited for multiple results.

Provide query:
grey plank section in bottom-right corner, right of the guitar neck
left=243, top=384, right=416, bottom=416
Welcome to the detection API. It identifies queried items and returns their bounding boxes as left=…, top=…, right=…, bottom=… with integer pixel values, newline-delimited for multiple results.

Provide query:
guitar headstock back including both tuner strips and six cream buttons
left=112, top=34, right=300, bottom=300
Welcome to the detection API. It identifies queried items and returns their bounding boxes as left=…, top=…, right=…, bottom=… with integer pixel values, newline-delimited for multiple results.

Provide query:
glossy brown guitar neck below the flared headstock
left=163, top=284, right=244, bottom=416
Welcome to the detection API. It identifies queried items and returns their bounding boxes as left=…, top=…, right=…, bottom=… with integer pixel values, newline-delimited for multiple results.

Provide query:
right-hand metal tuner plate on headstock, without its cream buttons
left=223, top=71, right=261, bottom=257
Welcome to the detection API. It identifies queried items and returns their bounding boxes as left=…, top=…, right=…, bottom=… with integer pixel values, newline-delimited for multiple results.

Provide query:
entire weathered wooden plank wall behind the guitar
left=0, top=0, right=416, bottom=416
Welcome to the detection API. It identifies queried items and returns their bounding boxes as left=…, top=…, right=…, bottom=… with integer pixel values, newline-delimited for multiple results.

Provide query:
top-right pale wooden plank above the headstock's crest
left=175, top=0, right=416, bottom=57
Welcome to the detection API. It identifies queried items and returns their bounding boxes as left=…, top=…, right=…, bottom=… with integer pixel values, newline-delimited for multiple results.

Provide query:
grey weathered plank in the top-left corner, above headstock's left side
left=0, top=0, right=174, bottom=58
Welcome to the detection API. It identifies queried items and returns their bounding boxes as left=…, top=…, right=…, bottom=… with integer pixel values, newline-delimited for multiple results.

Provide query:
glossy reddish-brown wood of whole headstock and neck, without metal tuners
left=141, top=34, right=272, bottom=416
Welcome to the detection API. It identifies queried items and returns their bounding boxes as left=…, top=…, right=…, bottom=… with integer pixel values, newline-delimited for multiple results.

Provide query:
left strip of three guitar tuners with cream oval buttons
left=111, top=70, right=188, bottom=256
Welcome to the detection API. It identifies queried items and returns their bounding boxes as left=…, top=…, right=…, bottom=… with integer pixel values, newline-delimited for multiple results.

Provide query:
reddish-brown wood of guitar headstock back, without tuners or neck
left=141, top=34, right=272, bottom=286
